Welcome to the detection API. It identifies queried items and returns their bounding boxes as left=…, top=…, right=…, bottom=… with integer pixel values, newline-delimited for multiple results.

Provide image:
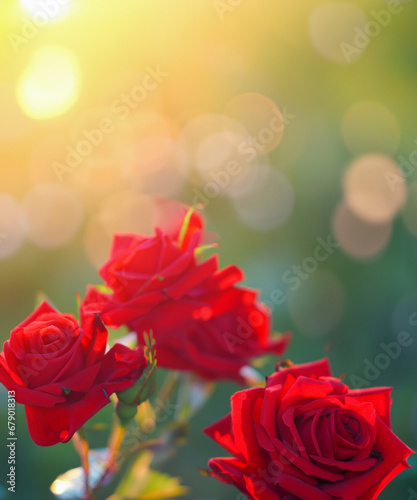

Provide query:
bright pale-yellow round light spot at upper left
left=17, top=45, right=80, bottom=120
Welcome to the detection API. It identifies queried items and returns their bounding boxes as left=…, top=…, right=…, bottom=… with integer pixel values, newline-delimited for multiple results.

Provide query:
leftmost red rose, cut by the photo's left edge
left=0, top=302, right=146, bottom=446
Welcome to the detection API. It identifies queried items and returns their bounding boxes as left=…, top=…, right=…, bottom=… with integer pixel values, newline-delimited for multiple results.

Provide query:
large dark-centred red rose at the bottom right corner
left=205, top=360, right=412, bottom=500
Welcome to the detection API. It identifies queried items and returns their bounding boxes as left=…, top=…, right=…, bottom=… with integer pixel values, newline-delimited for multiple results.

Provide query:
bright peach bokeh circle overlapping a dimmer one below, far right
left=343, top=154, right=407, bottom=224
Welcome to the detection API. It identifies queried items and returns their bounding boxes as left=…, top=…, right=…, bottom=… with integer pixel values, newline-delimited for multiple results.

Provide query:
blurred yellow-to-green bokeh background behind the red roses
left=0, top=0, right=417, bottom=500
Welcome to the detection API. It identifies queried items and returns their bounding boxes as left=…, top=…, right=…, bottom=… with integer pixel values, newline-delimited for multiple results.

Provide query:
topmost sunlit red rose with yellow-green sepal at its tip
left=91, top=209, right=210, bottom=320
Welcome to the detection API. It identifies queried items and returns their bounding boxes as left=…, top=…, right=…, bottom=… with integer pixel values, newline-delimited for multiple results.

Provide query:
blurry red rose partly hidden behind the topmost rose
left=120, top=266, right=290, bottom=383
